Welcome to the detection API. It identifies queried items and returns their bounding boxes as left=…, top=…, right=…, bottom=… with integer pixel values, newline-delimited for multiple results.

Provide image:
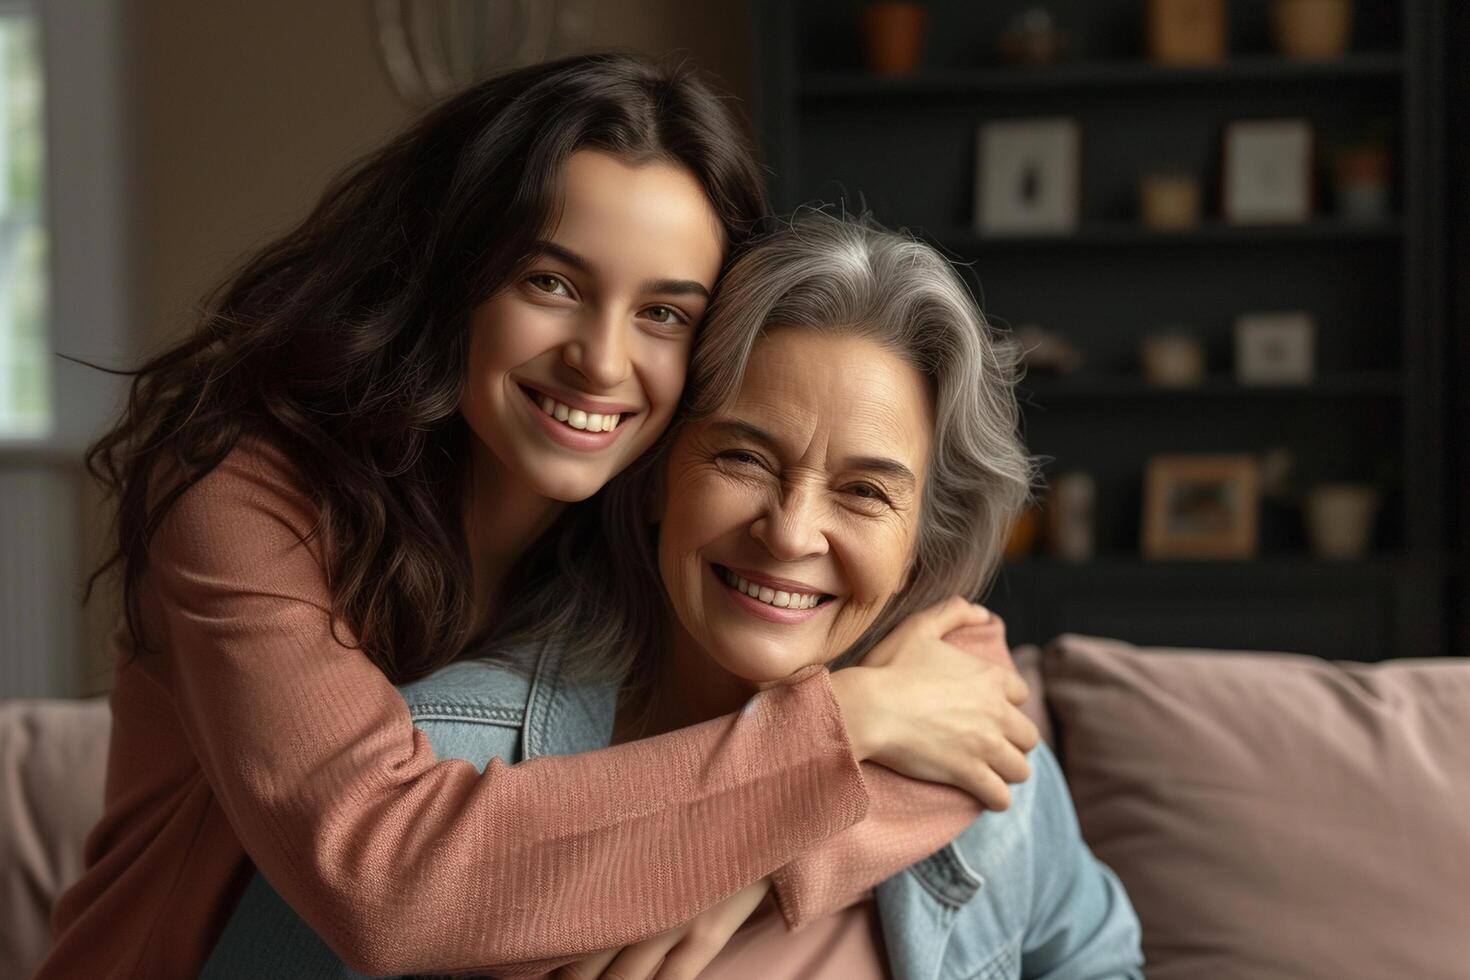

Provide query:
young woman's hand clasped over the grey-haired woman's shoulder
left=831, top=597, right=1041, bottom=810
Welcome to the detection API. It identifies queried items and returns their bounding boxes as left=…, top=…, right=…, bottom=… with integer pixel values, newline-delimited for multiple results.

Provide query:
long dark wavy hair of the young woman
left=74, top=53, right=766, bottom=682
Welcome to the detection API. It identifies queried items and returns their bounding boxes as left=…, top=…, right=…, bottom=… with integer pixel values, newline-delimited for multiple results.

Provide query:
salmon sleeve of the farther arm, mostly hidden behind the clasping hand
left=772, top=616, right=1014, bottom=930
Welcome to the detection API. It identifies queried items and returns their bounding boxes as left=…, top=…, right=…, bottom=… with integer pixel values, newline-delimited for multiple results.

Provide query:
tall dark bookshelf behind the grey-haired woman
left=753, top=0, right=1446, bottom=660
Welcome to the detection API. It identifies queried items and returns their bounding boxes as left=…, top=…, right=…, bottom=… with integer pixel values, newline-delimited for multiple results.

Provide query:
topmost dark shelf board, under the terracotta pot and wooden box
left=798, top=51, right=1404, bottom=100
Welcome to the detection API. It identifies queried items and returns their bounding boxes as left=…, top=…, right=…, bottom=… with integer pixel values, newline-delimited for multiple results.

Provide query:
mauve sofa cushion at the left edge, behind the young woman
left=0, top=698, right=112, bottom=977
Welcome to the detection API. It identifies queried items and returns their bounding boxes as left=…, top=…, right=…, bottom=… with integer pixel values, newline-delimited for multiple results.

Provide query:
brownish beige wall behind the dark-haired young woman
left=125, top=0, right=751, bottom=348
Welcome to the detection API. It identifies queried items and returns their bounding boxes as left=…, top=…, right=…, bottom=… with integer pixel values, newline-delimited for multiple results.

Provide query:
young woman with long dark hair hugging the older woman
left=40, top=56, right=1014, bottom=977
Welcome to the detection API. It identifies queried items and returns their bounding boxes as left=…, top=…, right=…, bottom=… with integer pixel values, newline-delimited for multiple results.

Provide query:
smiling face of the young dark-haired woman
left=460, top=150, right=725, bottom=501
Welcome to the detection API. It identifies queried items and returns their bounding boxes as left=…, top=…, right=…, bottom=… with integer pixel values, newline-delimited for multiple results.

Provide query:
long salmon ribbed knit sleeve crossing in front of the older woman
left=144, top=440, right=869, bottom=974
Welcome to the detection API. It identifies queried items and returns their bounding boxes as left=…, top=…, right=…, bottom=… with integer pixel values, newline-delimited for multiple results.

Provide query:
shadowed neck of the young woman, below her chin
left=465, top=441, right=566, bottom=632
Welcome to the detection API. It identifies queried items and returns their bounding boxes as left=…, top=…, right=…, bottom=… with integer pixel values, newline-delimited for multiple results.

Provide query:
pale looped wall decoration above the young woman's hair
left=372, top=0, right=592, bottom=106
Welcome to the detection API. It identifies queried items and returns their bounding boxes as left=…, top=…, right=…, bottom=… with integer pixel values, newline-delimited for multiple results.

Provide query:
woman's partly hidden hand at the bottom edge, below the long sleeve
left=551, top=879, right=770, bottom=980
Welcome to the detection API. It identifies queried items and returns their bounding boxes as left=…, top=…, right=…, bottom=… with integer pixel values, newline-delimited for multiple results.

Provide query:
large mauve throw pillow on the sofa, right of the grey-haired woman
left=1042, top=635, right=1470, bottom=980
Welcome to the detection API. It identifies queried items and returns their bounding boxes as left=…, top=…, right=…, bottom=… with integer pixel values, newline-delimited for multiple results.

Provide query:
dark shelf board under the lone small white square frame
left=1017, top=370, right=1402, bottom=407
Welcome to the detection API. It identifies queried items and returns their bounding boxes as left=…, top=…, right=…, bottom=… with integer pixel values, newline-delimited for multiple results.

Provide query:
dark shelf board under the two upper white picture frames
left=929, top=217, right=1404, bottom=253
